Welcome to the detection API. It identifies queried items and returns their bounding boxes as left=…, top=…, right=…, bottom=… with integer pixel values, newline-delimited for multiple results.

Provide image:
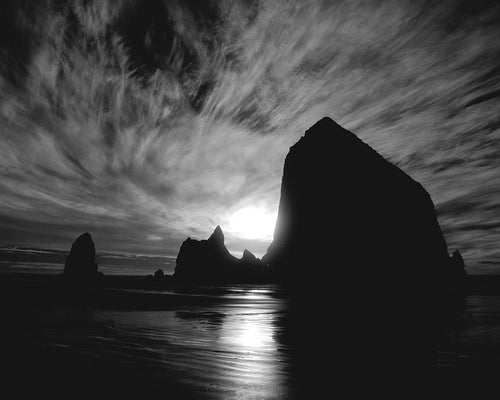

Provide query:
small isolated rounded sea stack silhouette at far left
left=64, top=232, right=99, bottom=280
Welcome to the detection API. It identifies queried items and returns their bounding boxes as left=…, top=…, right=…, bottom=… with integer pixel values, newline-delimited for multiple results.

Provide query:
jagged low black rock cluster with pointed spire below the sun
left=174, top=226, right=268, bottom=283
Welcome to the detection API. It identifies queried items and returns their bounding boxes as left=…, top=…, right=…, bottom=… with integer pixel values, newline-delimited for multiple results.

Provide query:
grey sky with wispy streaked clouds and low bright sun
left=0, top=0, right=500, bottom=273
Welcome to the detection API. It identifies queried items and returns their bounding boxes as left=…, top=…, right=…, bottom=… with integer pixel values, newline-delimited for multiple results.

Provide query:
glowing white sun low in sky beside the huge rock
left=227, top=207, right=276, bottom=239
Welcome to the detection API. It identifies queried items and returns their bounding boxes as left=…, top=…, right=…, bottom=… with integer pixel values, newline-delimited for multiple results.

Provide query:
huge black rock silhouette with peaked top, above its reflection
left=265, top=118, right=463, bottom=284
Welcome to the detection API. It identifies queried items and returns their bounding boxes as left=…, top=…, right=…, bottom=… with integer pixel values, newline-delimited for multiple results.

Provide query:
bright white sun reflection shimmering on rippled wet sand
left=169, top=288, right=288, bottom=399
